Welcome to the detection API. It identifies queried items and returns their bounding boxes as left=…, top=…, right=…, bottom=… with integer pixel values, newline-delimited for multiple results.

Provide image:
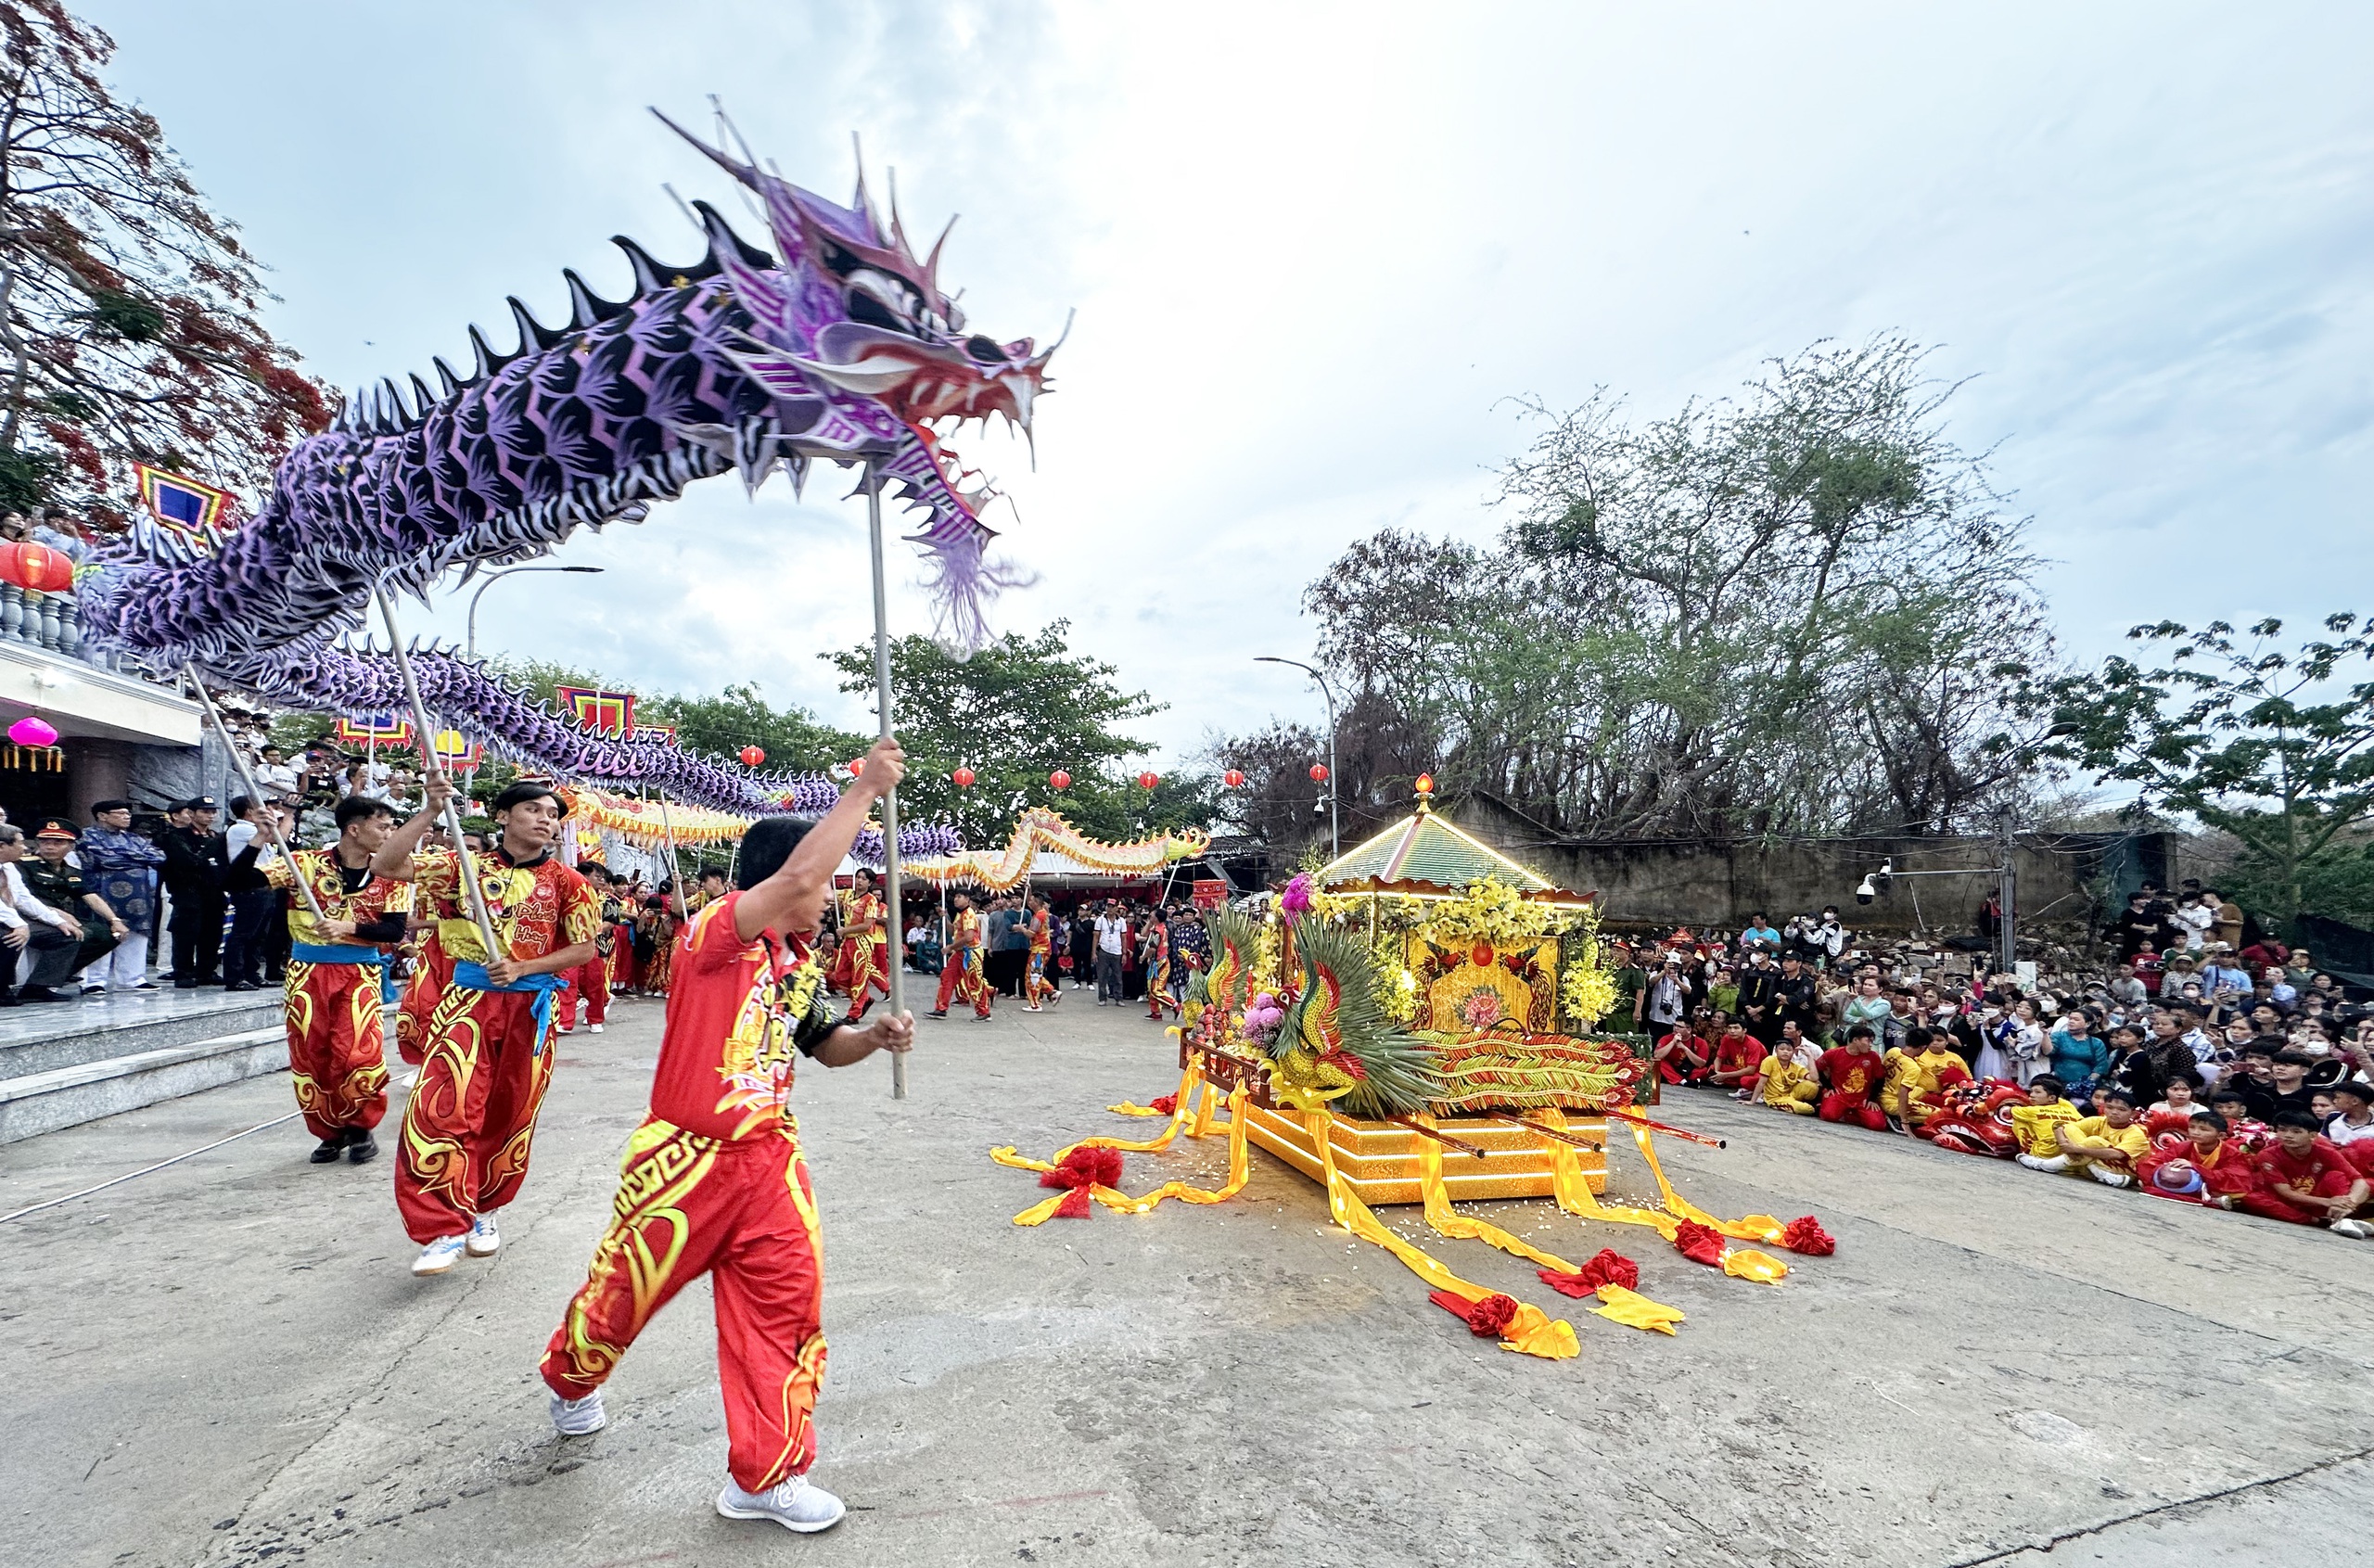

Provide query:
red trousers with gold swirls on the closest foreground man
left=543, top=1119, right=823, bottom=1492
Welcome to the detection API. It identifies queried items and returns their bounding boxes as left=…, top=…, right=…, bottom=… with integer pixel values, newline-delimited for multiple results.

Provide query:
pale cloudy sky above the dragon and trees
left=83, top=0, right=2374, bottom=759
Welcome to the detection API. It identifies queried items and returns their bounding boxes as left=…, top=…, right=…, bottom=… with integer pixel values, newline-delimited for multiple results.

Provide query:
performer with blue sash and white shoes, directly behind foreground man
left=373, top=773, right=601, bottom=1274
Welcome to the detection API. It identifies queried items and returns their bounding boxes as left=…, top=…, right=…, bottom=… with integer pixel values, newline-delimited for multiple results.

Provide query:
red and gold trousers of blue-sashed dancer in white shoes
left=397, top=985, right=558, bottom=1243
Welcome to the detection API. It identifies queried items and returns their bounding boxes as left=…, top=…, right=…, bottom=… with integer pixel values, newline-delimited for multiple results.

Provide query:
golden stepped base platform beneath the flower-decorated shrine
left=1244, top=1105, right=1607, bottom=1207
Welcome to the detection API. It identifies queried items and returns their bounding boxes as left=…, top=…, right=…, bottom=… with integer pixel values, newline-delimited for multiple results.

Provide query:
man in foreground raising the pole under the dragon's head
left=542, top=740, right=914, bottom=1533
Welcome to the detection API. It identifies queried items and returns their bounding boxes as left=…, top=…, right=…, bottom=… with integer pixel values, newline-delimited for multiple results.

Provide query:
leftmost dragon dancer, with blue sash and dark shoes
left=263, top=795, right=413, bottom=1165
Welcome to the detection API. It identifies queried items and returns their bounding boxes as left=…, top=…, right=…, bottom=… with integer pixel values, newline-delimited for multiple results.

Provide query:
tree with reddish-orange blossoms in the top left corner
left=0, top=0, right=330, bottom=529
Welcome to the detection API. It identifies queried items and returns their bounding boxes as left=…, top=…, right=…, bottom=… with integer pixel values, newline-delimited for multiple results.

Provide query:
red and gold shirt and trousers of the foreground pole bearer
left=543, top=894, right=836, bottom=1492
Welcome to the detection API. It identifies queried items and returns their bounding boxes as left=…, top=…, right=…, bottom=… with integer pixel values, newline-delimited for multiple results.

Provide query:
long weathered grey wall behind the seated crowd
left=1449, top=797, right=2153, bottom=932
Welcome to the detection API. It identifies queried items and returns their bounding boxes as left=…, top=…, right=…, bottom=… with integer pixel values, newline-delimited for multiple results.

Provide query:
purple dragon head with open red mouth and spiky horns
left=653, top=109, right=1071, bottom=647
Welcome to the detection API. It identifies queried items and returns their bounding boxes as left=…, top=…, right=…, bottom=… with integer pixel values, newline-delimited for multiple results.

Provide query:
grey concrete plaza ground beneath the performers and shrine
left=0, top=994, right=2374, bottom=1568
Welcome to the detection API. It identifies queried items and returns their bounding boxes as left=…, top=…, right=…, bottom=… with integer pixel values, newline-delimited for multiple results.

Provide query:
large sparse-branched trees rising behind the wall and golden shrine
left=1262, top=337, right=2053, bottom=837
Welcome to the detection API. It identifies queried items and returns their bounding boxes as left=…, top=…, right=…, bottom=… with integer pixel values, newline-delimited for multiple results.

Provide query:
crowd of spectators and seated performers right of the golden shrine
left=1607, top=883, right=2374, bottom=1238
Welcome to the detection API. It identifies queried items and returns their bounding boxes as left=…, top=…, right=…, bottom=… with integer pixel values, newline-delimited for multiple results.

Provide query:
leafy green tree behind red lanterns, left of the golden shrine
left=823, top=621, right=1196, bottom=845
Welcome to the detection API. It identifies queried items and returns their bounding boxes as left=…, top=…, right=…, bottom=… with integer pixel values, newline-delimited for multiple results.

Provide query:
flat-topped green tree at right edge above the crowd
left=2039, top=615, right=2374, bottom=921
